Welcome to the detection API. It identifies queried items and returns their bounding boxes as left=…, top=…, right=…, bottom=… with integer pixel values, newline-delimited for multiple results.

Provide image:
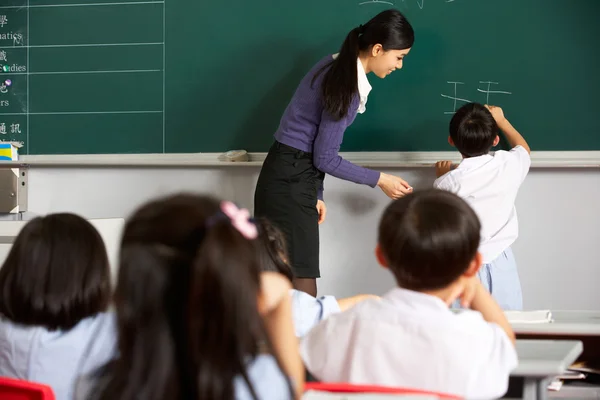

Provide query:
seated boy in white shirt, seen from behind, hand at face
left=301, top=189, right=517, bottom=399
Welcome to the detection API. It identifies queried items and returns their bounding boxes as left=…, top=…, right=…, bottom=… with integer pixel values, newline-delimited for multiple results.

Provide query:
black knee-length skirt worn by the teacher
left=254, top=142, right=325, bottom=278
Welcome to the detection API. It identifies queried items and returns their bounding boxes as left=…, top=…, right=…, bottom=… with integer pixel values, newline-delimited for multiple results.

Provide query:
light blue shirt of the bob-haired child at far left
left=0, top=313, right=117, bottom=400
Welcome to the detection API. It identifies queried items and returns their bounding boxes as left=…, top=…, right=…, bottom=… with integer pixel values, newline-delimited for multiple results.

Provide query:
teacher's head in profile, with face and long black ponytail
left=322, top=9, right=415, bottom=119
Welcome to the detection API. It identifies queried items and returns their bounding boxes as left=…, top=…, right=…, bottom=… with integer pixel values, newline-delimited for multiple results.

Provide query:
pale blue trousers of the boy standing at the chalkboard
left=452, top=247, right=523, bottom=310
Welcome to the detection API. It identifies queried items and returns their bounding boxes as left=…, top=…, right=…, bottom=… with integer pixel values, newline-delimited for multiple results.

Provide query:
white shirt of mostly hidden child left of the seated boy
left=290, top=289, right=340, bottom=338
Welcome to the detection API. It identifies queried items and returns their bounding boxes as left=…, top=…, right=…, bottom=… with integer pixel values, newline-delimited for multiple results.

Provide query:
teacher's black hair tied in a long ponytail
left=313, top=9, right=415, bottom=119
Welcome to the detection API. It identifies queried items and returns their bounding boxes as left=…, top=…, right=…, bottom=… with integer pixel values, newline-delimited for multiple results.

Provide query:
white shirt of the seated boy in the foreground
left=300, top=288, right=517, bottom=399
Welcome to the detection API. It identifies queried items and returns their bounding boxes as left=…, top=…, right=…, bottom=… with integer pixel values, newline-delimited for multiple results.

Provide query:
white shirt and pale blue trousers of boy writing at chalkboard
left=434, top=146, right=531, bottom=310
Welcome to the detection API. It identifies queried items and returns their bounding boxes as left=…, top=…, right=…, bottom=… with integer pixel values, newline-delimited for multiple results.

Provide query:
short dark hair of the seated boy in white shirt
left=379, top=189, right=481, bottom=291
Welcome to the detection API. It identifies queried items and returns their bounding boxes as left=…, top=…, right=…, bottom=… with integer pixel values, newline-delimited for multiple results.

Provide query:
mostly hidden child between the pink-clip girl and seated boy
left=254, top=218, right=379, bottom=338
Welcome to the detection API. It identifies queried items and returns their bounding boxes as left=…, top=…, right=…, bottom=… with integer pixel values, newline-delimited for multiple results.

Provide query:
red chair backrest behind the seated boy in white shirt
left=303, top=382, right=460, bottom=400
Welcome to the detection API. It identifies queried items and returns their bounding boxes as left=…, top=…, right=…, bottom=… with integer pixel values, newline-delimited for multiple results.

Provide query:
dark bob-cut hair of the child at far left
left=0, top=213, right=111, bottom=330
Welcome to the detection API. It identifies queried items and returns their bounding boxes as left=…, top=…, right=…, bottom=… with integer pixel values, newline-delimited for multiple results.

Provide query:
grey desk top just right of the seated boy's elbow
left=511, top=339, right=583, bottom=377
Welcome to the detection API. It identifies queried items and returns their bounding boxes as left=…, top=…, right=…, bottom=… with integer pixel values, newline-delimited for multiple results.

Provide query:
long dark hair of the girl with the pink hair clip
left=97, top=194, right=292, bottom=400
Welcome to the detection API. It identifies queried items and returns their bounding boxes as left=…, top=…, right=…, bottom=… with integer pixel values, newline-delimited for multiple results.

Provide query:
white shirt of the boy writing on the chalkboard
left=433, top=146, right=531, bottom=264
